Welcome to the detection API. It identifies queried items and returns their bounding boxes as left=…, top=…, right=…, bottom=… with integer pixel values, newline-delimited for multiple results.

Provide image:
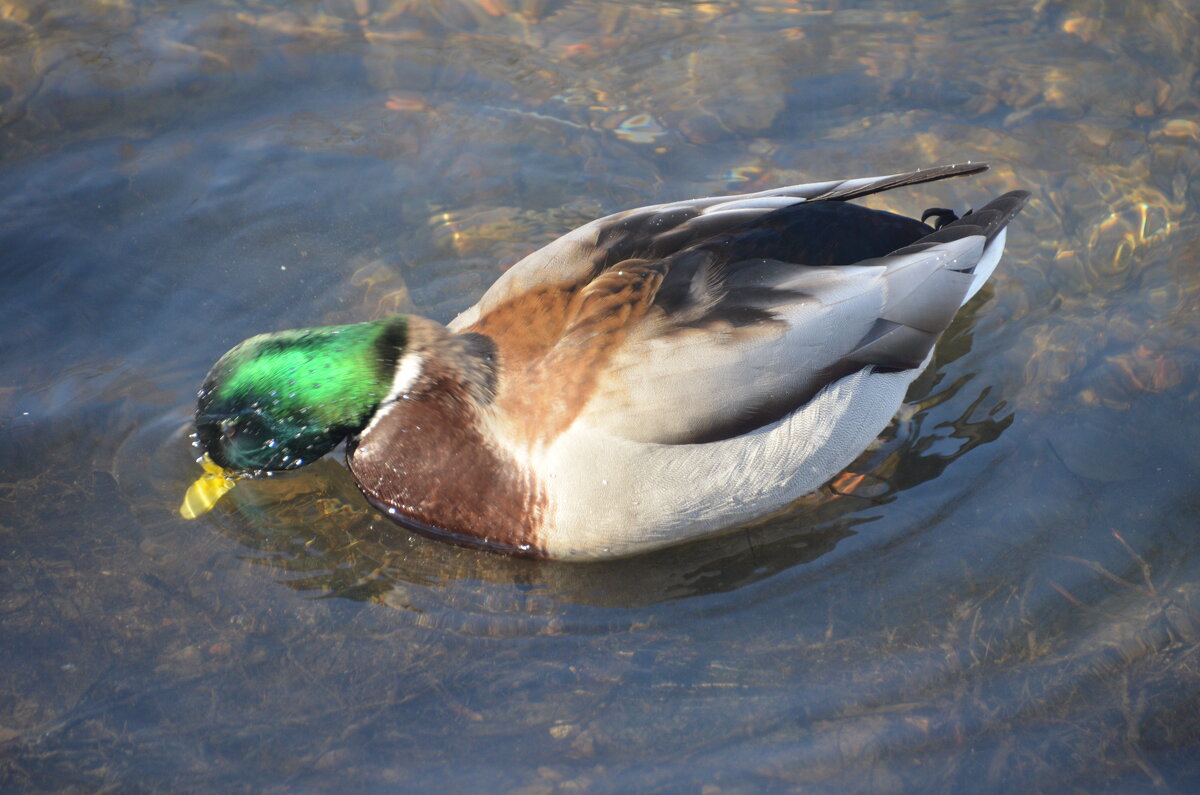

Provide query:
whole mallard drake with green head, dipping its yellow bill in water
left=182, top=163, right=1028, bottom=560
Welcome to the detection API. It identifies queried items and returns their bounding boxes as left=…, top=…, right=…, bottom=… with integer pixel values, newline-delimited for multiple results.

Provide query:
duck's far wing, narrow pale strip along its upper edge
left=450, top=163, right=988, bottom=334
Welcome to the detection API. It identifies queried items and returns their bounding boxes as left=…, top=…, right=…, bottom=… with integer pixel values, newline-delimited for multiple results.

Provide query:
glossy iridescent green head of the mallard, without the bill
left=196, top=316, right=408, bottom=472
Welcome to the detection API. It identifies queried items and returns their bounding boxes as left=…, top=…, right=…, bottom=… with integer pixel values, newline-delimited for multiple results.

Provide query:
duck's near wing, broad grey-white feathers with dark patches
left=578, top=191, right=1027, bottom=443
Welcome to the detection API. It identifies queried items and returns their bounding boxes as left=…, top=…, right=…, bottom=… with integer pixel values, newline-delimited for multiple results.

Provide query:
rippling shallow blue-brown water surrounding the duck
left=0, top=0, right=1200, bottom=795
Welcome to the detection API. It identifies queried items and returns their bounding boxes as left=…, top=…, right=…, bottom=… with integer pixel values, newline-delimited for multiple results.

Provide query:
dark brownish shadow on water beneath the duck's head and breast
left=217, top=461, right=871, bottom=606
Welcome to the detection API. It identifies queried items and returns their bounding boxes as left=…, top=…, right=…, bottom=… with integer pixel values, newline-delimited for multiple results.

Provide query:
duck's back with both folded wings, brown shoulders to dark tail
left=451, top=167, right=1024, bottom=444
